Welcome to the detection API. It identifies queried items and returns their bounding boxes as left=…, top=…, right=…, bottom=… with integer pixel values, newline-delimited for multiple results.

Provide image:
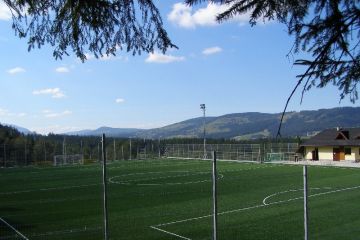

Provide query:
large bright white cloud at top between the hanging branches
left=167, top=2, right=249, bottom=28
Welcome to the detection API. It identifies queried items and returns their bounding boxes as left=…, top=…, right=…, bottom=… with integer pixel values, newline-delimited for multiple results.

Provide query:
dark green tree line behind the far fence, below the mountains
left=0, top=124, right=300, bottom=167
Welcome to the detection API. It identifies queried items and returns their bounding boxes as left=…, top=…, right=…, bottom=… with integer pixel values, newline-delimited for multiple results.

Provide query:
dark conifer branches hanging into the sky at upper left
left=4, top=0, right=176, bottom=61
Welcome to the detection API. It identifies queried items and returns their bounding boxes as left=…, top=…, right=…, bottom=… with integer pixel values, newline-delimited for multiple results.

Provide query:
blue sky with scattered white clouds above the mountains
left=0, top=0, right=359, bottom=134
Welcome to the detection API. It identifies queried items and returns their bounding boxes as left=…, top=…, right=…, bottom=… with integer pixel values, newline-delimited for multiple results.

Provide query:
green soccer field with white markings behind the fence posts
left=0, top=159, right=360, bottom=240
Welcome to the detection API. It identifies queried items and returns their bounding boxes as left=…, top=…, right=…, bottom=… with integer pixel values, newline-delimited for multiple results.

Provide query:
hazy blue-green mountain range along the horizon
left=66, top=107, right=360, bottom=140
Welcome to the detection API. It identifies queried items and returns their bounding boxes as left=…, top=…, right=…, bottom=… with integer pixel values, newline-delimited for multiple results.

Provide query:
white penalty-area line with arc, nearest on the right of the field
left=150, top=185, right=360, bottom=240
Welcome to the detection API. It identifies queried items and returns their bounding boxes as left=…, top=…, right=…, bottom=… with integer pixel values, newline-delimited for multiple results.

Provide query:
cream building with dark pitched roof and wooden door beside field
left=300, top=128, right=360, bottom=162
